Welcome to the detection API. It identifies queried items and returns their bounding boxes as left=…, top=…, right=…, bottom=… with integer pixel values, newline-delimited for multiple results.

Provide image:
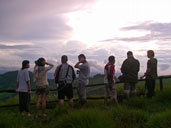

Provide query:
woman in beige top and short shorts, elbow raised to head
left=33, top=58, right=53, bottom=118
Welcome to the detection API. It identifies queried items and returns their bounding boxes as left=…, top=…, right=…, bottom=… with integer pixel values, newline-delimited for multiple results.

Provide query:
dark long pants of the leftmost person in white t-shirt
left=19, top=92, right=30, bottom=112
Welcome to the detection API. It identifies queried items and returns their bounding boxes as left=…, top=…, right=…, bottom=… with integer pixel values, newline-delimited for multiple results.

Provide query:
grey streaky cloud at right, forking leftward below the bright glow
left=102, top=22, right=171, bottom=42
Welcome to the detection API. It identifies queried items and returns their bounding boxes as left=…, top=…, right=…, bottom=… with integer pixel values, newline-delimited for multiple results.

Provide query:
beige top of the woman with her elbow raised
left=36, top=66, right=52, bottom=86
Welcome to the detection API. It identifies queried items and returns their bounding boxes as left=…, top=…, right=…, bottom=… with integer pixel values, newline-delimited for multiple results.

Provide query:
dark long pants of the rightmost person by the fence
left=145, top=79, right=155, bottom=98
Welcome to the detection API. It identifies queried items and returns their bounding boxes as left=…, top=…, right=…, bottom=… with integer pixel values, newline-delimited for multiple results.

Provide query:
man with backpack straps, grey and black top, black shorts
left=55, top=55, right=76, bottom=109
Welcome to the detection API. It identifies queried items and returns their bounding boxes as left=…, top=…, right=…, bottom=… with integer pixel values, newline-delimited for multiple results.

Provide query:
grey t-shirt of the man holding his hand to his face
left=78, top=62, right=90, bottom=84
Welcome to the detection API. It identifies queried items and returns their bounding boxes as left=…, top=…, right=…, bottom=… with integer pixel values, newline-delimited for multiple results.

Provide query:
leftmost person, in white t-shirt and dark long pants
left=15, top=60, right=31, bottom=116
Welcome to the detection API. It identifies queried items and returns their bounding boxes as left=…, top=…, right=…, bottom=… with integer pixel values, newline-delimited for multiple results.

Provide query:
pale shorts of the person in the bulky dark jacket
left=124, top=82, right=136, bottom=93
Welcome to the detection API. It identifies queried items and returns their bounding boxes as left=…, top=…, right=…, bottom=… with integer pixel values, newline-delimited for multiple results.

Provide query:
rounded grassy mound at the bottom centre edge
left=53, top=109, right=114, bottom=128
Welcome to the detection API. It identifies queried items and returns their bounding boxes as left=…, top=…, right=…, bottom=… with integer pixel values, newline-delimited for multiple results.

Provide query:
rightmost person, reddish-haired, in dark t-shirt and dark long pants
left=141, top=50, right=157, bottom=98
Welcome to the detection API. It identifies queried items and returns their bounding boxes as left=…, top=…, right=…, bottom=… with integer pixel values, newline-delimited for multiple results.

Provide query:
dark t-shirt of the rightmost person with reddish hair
left=146, top=58, right=157, bottom=80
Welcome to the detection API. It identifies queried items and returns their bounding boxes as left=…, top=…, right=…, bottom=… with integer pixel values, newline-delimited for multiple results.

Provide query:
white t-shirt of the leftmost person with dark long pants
left=17, top=69, right=30, bottom=92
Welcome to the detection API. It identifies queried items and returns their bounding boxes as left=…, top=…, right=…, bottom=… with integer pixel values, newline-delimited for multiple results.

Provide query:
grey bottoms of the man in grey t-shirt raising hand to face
left=77, top=81, right=87, bottom=105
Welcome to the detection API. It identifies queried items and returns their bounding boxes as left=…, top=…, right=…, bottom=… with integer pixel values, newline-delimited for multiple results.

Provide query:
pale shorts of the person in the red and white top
left=104, top=84, right=117, bottom=99
